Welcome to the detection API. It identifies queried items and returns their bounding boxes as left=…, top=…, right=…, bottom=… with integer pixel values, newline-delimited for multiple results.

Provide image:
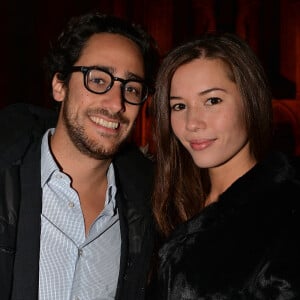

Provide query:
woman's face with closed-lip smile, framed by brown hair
left=170, top=58, right=250, bottom=169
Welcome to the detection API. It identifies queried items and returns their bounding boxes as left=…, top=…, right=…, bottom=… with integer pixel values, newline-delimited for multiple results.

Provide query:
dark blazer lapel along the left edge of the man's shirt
left=12, top=144, right=42, bottom=300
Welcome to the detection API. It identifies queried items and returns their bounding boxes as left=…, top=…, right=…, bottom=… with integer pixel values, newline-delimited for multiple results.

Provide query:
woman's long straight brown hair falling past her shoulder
left=151, top=33, right=272, bottom=236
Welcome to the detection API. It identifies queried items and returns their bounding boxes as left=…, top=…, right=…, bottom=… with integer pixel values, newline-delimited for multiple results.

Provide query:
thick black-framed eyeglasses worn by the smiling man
left=70, top=66, right=149, bottom=105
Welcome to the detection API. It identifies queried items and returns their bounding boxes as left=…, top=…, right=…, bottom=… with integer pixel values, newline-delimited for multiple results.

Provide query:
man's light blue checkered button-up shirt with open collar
left=39, top=129, right=121, bottom=300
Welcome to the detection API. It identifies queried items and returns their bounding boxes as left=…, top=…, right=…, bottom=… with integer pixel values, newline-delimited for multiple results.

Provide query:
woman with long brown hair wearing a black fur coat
left=149, top=33, right=300, bottom=300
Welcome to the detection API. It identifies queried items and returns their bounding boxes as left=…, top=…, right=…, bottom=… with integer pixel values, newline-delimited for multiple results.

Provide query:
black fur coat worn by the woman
left=149, top=154, right=300, bottom=300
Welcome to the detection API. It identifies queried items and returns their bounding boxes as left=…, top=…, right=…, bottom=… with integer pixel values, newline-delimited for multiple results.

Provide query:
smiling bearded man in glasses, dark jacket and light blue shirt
left=0, top=14, right=157, bottom=300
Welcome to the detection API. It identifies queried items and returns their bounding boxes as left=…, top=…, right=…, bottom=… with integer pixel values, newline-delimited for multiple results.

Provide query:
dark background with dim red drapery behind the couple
left=0, top=0, right=300, bottom=155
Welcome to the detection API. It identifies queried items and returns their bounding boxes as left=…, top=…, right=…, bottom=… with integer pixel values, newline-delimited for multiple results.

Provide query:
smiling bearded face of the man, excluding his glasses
left=53, top=33, right=144, bottom=159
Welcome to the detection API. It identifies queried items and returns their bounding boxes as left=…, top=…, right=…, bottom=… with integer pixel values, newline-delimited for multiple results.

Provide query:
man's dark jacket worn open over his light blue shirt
left=0, top=104, right=153, bottom=300
